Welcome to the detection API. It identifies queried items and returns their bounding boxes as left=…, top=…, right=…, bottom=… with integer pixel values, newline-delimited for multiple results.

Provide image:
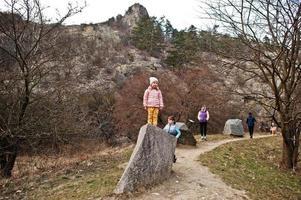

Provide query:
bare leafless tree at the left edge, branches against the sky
left=0, top=0, right=83, bottom=177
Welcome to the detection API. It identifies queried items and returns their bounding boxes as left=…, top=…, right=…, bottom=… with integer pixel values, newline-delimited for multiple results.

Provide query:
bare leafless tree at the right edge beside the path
left=202, top=0, right=301, bottom=169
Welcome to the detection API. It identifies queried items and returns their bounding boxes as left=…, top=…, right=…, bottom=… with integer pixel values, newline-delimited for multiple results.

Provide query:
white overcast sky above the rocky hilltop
left=0, top=0, right=211, bottom=29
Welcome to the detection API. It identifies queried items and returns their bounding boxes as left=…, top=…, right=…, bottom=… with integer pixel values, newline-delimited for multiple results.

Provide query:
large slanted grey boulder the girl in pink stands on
left=114, top=124, right=176, bottom=194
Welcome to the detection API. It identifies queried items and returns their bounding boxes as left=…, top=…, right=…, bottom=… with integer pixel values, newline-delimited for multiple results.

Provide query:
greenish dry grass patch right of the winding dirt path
left=200, top=136, right=301, bottom=200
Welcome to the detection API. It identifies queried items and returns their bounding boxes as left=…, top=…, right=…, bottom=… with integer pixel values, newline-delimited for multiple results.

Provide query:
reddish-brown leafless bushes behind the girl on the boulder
left=113, top=66, right=241, bottom=141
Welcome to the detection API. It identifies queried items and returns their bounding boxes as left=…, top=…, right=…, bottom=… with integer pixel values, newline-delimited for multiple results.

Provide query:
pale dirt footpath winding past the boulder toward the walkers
left=133, top=136, right=266, bottom=200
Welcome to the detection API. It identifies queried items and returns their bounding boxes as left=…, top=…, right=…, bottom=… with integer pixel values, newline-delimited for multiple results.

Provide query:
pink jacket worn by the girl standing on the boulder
left=143, top=86, right=164, bottom=108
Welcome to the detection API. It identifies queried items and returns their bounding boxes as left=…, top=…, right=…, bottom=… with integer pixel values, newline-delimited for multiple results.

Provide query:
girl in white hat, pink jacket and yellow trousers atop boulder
left=143, top=77, right=164, bottom=126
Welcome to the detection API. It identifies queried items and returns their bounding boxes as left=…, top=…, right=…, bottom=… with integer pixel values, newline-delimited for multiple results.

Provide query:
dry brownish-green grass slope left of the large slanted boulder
left=0, top=143, right=133, bottom=200
